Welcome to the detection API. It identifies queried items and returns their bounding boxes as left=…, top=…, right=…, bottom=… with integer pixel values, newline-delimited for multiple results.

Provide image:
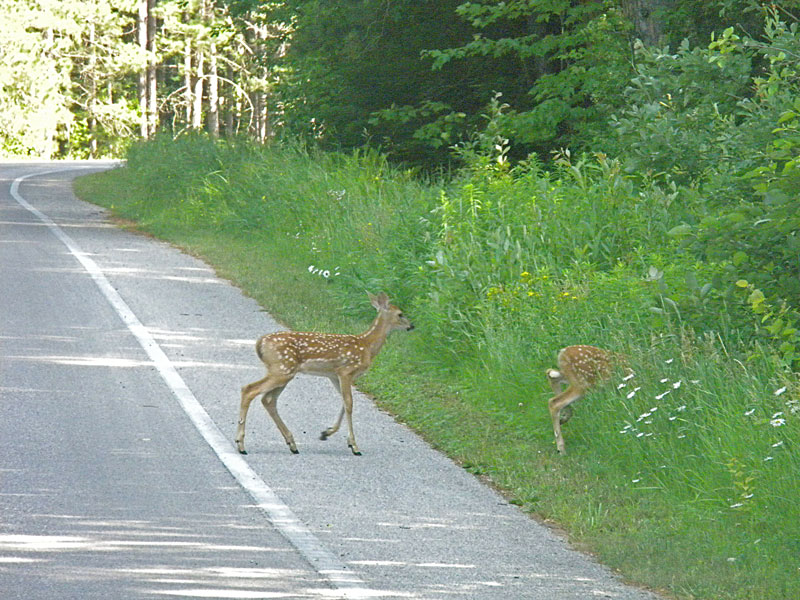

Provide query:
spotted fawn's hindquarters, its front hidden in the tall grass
left=546, top=345, right=624, bottom=454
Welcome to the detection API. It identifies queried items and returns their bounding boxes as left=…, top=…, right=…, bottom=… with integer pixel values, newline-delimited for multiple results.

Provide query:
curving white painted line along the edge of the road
left=10, top=167, right=368, bottom=598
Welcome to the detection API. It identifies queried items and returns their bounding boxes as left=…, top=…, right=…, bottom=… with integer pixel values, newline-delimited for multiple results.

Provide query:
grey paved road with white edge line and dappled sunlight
left=0, top=163, right=664, bottom=600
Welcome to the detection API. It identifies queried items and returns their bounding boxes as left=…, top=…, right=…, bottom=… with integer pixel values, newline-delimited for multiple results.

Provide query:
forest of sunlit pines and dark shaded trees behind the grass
left=0, top=0, right=798, bottom=168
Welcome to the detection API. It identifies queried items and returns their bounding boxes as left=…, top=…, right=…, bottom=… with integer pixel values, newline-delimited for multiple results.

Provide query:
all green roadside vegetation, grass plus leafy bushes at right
left=76, top=12, right=800, bottom=600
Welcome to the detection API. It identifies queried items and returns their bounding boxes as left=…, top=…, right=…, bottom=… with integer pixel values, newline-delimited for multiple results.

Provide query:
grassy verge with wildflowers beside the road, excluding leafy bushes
left=76, top=138, right=800, bottom=600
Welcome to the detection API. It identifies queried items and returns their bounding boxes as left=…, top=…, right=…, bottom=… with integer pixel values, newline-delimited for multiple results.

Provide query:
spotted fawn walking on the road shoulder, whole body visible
left=236, top=292, right=414, bottom=455
